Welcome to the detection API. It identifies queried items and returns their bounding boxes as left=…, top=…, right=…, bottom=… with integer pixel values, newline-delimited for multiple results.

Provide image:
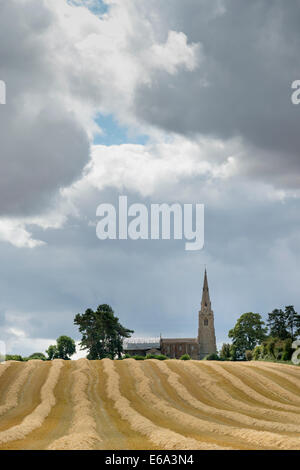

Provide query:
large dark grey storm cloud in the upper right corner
left=135, top=0, right=300, bottom=186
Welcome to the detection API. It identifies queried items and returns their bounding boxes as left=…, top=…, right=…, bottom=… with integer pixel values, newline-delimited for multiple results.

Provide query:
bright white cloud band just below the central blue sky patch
left=64, top=137, right=240, bottom=199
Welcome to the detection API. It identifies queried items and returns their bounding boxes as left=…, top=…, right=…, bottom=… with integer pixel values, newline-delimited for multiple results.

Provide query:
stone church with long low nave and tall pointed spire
left=124, top=269, right=217, bottom=359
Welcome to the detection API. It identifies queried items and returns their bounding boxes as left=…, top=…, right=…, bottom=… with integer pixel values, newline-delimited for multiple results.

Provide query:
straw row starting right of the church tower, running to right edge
left=227, top=364, right=300, bottom=413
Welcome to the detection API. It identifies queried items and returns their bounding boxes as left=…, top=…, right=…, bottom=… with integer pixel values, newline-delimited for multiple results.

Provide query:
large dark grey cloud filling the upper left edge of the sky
left=0, top=0, right=89, bottom=215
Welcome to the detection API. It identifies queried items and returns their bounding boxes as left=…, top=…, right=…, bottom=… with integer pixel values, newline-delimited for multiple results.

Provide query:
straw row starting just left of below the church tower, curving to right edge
left=180, top=361, right=300, bottom=429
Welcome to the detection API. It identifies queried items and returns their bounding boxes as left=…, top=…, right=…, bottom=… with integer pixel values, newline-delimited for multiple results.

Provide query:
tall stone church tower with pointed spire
left=198, top=269, right=217, bottom=359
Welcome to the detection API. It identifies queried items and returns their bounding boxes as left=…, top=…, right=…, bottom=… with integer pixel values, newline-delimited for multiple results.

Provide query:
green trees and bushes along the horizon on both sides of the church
left=6, top=304, right=300, bottom=361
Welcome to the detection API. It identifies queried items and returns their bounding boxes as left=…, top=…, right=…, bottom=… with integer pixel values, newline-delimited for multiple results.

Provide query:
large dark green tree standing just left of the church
left=74, top=304, right=133, bottom=359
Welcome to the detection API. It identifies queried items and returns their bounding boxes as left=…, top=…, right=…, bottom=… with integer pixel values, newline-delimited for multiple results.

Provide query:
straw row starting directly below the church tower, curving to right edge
left=204, top=361, right=299, bottom=414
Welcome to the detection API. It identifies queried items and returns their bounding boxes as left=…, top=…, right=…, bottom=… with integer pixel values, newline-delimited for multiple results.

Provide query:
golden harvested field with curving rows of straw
left=0, top=359, right=300, bottom=450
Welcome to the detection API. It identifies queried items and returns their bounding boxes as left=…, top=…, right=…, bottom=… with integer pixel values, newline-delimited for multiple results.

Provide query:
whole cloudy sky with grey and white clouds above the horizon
left=0, top=0, right=300, bottom=355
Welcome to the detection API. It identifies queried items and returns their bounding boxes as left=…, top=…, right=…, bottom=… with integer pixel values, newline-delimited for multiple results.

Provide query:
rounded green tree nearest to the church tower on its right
left=228, top=312, right=267, bottom=360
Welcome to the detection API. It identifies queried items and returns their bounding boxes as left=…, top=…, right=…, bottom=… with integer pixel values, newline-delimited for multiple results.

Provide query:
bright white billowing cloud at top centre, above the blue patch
left=41, top=0, right=201, bottom=130
